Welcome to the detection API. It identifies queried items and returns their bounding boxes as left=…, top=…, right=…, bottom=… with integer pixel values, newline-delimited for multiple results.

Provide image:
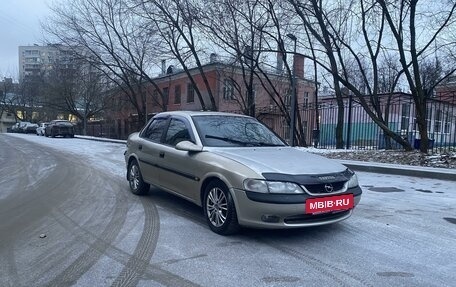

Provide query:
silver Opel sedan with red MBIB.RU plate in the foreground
left=125, top=111, right=362, bottom=235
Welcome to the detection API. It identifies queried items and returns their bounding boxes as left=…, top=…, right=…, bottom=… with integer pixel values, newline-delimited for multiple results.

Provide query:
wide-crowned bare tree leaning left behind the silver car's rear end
left=43, top=0, right=166, bottom=126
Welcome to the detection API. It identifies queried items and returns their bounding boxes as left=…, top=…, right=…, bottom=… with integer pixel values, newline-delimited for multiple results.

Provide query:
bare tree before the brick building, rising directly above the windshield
left=198, top=0, right=276, bottom=116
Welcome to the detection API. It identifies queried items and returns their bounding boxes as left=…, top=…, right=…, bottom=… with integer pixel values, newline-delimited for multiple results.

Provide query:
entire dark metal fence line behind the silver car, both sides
left=76, top=95, right=456, bottom=152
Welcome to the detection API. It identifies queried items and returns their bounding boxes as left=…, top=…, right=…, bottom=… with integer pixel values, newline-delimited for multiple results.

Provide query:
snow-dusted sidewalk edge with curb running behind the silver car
left=75, top=135, right=456, bottom=181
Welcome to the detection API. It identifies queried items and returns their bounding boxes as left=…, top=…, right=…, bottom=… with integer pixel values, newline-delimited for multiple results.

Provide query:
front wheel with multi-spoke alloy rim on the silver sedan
left=203, top=180, right=240, bottom=235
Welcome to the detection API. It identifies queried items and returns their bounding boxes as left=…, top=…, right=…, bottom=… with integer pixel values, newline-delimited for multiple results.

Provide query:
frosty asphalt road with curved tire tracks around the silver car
left=0, top=134, right=456, bottom=286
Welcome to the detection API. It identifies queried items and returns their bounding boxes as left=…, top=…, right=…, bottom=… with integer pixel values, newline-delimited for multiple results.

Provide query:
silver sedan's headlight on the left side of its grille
left=244, top=179, right=304, bottom=194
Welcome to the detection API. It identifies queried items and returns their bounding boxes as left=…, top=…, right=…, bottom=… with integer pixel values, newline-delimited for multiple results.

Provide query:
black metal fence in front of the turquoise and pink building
left=300, top=95, right=456, bottom=152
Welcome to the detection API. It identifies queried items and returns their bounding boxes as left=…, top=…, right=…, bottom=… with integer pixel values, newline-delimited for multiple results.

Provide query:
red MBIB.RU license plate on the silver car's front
left=306, top=194, right=354, bottom=214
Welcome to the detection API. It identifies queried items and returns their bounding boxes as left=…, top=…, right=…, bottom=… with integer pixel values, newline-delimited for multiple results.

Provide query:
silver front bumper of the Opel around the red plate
left=232, top=187, right=362, bottom=229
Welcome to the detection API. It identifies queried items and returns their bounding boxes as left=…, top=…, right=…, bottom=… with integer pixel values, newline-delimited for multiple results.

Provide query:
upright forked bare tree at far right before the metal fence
left=377, top=0, right=456, bottom=152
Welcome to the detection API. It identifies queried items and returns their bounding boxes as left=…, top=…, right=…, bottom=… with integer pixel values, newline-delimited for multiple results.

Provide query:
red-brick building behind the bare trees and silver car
left=110, top=55, right=315, bottom=142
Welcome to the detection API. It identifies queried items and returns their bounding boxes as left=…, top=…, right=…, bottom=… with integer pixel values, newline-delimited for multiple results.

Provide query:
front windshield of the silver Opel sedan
left=193, top=115, right=285, bottom=147
